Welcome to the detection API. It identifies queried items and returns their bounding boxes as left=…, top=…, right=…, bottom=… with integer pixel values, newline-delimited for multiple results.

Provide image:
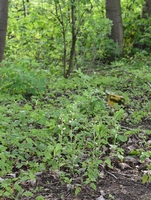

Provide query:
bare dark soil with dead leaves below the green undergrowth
left=15, top=121, right=151, bottom=200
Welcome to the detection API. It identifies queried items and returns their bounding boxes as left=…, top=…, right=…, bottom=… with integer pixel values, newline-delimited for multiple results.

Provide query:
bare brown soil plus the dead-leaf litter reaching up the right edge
left=0, top=83, right=151, bottom=200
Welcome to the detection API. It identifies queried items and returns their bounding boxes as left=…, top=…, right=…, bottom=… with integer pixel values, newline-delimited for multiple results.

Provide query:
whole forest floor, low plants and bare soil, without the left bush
left=0, top=61, right=151, bottom=200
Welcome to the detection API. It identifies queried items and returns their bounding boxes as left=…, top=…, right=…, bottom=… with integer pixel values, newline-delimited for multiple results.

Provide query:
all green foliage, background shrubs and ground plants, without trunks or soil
left=0, top=0, right=151, bottom=199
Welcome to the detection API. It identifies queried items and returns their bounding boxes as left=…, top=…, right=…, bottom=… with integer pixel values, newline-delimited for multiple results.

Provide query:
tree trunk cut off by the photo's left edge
left=0, top=0, right=8, bottom=62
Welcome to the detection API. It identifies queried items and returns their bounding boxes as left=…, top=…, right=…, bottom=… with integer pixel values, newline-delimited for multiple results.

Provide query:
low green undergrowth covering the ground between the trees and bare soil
left=0, top=59, right=151, bottom=198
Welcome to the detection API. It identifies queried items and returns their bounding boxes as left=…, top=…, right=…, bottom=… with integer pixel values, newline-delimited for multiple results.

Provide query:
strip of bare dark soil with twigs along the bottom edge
left=20, top=170, right=151, bottom=200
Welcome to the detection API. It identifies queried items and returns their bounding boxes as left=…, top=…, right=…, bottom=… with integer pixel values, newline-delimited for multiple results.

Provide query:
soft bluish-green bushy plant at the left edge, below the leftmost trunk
left=0, top=60, right=46, bottom=97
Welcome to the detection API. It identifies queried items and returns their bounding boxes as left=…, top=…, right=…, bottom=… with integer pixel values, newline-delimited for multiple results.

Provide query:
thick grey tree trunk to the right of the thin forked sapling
left=106, top=0, right=123, bottom=54
